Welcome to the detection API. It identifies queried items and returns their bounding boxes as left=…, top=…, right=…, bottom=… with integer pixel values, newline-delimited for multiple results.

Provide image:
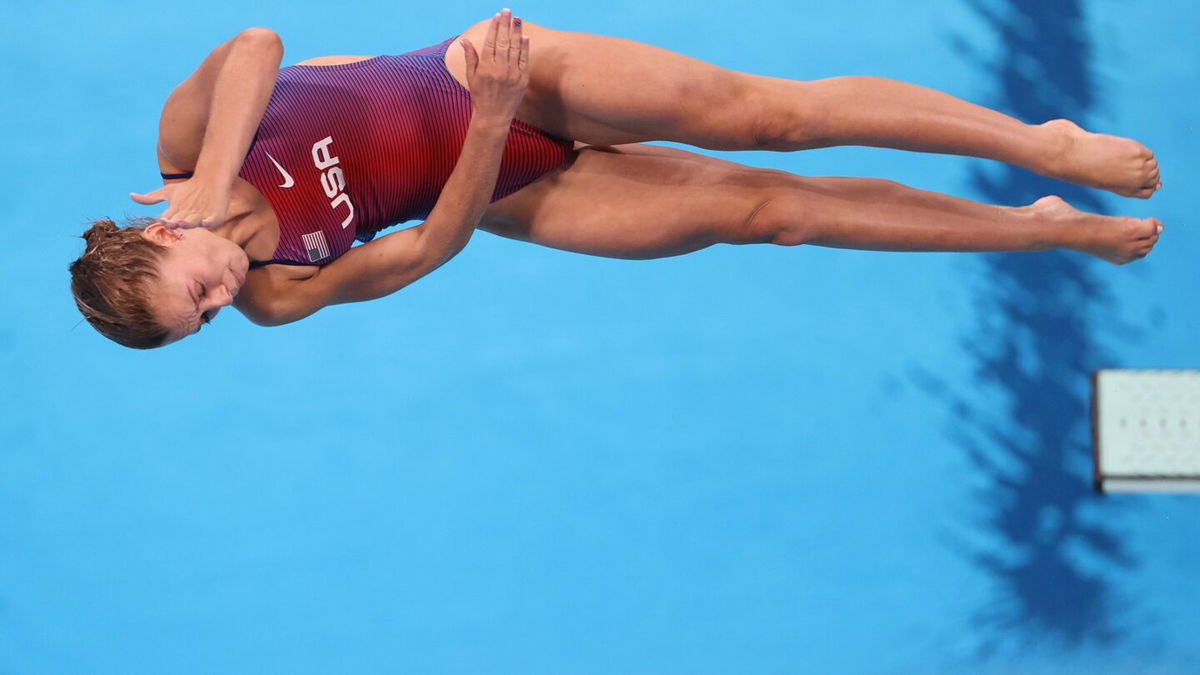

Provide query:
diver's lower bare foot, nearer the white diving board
left=1027, top=195, right=1163, bottom=264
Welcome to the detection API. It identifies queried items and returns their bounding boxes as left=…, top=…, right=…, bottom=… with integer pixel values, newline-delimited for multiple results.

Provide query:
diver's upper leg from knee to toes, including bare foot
left=752, top=76, right=1158, bottom=197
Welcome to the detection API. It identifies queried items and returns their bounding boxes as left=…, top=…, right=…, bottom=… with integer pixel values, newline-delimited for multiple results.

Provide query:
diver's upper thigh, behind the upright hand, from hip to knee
left=446, top=19, right=787, bottom=150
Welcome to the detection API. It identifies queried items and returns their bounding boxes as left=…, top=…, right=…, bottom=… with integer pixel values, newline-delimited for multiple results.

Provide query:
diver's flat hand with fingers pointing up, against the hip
left=462, top=10, right=529, bottom=121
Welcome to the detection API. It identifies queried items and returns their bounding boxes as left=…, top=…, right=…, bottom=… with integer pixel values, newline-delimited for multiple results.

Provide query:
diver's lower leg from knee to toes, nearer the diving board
left=756, top=178, right=1159, bottom=263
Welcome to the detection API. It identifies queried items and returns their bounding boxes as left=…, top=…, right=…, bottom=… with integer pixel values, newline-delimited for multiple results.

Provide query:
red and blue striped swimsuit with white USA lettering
left=163, top=37, right=574, bottom=267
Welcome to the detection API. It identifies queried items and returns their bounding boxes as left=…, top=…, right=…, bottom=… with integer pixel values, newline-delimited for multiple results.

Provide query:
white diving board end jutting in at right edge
left=1092, top=370, right=1200, bottom=494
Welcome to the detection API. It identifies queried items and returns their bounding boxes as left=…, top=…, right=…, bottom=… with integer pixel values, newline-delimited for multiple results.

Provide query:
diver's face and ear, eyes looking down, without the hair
left=143, top=223, right=250, bottom=344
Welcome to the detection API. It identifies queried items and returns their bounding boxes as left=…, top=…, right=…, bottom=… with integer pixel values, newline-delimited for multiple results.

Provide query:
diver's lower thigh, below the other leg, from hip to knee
left=479, top=144, right=798, bottom=259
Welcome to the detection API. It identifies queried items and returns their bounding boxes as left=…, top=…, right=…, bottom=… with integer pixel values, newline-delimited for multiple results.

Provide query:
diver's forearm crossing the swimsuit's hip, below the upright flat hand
left=419, top=114, right=512, bottom=268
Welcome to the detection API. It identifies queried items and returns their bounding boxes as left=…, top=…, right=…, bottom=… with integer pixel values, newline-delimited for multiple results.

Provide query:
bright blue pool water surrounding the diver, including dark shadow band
left=0, top=0, right=1200, bottom=674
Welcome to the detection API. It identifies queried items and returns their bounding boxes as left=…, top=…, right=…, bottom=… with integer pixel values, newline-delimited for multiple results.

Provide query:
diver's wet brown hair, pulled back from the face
left=70, top=217, right=168, bottom=350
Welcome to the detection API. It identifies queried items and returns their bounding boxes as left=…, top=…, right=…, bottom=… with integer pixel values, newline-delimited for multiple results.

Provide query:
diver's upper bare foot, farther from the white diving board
left=1040, top=120, right=1162, bottom=199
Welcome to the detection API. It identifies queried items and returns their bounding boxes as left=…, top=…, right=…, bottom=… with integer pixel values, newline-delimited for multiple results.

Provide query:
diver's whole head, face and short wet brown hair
left=71, top=217, right=250, bottom=350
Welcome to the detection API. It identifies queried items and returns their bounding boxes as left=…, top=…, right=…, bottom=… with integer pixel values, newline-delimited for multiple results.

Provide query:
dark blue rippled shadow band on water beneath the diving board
left=913, top=0, right=1138, bottom=659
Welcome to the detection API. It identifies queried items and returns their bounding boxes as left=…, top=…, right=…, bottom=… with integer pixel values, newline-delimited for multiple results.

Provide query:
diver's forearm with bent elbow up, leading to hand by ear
left=196, top=29, right=283, bottom=186
